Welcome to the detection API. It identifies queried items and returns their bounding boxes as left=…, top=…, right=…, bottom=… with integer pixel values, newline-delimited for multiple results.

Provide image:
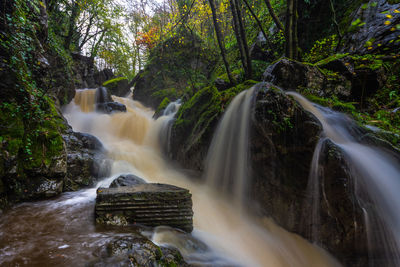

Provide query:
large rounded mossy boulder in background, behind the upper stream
left=133, top=27, right=217, bottom=109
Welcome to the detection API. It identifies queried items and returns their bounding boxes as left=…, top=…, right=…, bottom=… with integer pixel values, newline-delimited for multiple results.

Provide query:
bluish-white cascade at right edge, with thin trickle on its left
left=287, top=92, right=400, bottom=266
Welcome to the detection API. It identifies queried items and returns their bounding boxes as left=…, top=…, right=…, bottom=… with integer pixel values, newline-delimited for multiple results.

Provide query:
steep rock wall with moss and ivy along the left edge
left=0, top=0, right=108, bottom=209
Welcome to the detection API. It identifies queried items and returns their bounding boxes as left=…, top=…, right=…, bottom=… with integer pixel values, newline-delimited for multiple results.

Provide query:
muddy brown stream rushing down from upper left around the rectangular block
left=0, top=90, right=338, bottom=266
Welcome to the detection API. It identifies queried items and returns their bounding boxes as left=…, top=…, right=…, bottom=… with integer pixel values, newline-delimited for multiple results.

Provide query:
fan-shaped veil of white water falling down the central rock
left=205, top=87, right=255, bottom=206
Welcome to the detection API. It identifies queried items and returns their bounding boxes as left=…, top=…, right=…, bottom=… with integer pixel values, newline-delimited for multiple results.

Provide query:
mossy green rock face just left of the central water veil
left=168, top=80, right=256, bottom=171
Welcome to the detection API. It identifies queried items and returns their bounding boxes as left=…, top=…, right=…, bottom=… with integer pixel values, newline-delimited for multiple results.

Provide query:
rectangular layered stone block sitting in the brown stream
left=95, top=183, right=193, bottom=232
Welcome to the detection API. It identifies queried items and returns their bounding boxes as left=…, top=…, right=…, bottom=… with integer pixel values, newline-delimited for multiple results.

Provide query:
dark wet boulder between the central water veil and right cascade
left=249, top=84, right=322, bottom=226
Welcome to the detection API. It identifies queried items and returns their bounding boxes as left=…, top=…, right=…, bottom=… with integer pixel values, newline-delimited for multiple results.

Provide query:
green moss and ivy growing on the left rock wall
left=0, top=0, right=68, bottom=203
